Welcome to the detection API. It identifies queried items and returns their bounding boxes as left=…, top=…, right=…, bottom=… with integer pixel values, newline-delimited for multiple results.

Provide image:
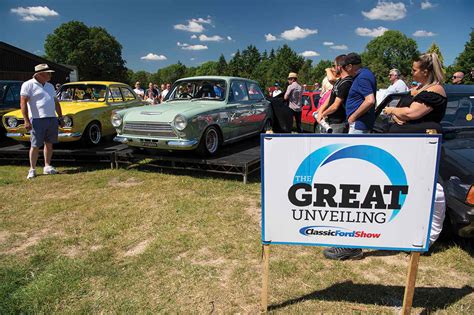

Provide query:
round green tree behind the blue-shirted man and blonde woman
left=362, top=31, right=419, bottom=87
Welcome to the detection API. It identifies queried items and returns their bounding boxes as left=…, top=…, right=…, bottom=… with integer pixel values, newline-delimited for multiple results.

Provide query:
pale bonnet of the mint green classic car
left=122, top=101, right=224, bottom=122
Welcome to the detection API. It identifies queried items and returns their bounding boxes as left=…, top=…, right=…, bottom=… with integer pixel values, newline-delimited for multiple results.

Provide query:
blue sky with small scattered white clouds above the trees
left=0, top=0, right=474, bottom=72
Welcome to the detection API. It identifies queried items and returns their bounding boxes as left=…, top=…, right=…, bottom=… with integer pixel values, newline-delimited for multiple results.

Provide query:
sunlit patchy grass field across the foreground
left=0, top=166, right=474, bottom=314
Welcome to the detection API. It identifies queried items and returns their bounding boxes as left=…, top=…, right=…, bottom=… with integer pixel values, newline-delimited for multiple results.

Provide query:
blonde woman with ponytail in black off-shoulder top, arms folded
left=384, top=53, right=448, bottom=133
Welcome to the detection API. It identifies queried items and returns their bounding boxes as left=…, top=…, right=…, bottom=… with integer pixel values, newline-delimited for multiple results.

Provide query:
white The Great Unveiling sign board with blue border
left=261, top=134, right=440, bottom=251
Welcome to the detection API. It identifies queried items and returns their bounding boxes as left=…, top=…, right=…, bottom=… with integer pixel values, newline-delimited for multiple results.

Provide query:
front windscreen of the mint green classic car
left=167, top=79, right=227, bottom=101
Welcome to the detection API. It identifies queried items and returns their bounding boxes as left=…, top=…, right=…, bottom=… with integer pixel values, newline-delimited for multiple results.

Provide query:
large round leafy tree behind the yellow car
left=44, top=21, right=128, bottom=82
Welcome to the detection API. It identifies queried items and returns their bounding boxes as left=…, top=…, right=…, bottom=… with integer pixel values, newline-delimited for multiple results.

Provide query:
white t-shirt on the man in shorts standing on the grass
left=20, top=78, right=56, bottom=119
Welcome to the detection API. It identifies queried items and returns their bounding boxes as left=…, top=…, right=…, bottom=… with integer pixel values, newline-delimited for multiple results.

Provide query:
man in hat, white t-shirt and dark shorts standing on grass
left=20, top=63, right=64, bottom=179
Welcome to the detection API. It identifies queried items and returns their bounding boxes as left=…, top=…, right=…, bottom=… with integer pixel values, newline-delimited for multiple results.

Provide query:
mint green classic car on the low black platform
left=111, top=76, right=272, bottom=155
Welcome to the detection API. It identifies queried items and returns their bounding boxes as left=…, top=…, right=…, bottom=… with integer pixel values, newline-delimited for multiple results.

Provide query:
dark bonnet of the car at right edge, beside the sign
left=441, top=137, right=474, bottom=183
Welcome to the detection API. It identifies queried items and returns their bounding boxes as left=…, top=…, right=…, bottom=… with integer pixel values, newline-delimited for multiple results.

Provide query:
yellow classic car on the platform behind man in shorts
left=2, top=81, right=145, bottom=145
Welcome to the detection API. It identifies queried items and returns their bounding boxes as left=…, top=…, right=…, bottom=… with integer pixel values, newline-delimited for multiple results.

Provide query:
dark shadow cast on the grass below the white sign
left=268, top=281, right=474, bottom=313
